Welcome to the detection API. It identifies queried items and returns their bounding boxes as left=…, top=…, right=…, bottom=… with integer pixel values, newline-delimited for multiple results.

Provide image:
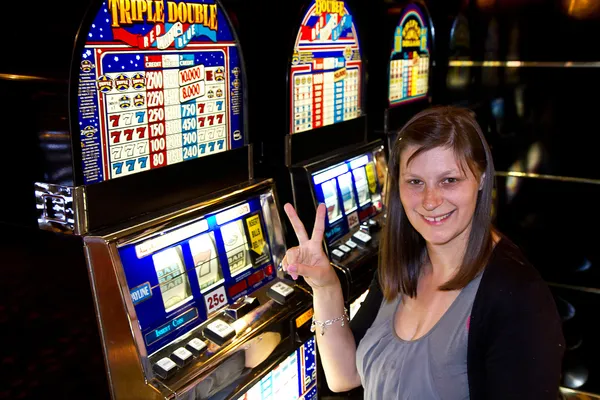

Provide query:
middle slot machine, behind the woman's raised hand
left=232, top=0, right=386, bottom=318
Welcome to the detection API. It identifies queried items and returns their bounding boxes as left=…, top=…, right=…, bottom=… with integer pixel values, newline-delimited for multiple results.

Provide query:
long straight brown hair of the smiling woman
left=379, top=106, right=494, bottom=300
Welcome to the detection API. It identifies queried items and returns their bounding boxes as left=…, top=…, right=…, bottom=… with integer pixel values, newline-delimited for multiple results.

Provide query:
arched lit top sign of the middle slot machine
left=290, top=0, right=362, bottom=133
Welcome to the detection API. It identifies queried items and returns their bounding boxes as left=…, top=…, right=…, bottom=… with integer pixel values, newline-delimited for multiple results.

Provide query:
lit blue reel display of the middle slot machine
left=312, top=148, right=387, bottom=244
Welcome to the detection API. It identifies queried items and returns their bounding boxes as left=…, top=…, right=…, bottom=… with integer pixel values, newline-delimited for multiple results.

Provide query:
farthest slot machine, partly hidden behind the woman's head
left=368, top=0, right=435, bottom=149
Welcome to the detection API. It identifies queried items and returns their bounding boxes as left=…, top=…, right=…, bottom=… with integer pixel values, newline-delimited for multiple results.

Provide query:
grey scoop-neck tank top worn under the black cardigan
left=356, top=274, right=482, bottom=400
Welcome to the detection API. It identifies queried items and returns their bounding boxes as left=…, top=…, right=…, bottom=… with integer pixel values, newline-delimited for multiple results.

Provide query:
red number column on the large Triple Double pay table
left=145, top=56, right=167, bottom=168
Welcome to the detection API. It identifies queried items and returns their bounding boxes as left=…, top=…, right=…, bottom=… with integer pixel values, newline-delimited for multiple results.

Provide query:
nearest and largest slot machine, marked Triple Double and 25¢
left=2, top=0, right=316, bottom=399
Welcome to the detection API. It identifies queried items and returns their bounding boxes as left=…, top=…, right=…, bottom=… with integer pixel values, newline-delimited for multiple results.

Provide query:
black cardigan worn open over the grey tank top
left=350, top=238, right=565, bottom=400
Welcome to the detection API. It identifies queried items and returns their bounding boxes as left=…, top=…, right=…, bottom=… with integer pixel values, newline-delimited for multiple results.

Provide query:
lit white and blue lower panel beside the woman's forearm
left=236, top=337, right=317, bottom=400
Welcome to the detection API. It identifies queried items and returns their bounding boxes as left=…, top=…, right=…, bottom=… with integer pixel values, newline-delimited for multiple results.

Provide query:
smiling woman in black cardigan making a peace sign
left=284, top=107, right=564, bottom=400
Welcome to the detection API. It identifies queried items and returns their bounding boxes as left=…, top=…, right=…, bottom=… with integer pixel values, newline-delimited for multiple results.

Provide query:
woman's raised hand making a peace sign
left=283, top=203, right=339, bottom=290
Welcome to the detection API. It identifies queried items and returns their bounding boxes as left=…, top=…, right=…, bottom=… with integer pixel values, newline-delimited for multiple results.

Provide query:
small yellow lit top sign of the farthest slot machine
left=388, top=4, right=431, bottom=106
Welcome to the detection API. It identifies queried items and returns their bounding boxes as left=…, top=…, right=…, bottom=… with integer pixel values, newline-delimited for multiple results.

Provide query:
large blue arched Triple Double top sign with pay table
left=77, top=0, right=245, bottom=184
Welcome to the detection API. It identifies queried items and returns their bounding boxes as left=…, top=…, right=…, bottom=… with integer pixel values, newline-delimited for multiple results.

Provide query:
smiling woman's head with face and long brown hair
left=379, top=107, right=494, bottom=299
